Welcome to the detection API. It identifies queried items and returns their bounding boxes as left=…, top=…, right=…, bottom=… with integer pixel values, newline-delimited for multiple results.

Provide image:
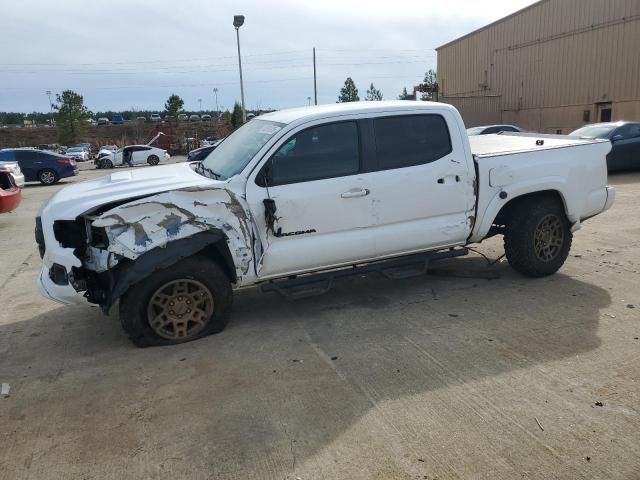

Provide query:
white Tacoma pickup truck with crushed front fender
left=36, top=101, right=615, bottom=345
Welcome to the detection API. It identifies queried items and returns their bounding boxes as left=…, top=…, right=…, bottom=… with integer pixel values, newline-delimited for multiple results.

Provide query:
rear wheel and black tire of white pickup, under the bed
left=504, top=197, right=573, bottom=277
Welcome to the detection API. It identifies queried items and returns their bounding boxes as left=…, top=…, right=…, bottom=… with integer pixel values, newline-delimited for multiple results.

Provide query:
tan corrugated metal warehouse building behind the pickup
left=436, top=0, right=640, bottom=134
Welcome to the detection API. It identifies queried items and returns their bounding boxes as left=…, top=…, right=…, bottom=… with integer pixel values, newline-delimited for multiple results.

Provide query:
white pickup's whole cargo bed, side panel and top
left=469, top=133, right=613, bottom=242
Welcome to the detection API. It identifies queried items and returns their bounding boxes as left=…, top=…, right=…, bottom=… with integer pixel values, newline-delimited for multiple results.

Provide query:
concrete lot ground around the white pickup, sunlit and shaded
left=0, top=161, right=640, bottom=480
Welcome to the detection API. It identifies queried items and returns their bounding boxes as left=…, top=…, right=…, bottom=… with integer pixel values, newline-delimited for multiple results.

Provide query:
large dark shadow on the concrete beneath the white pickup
left=0, top=258, right=610, bottom=478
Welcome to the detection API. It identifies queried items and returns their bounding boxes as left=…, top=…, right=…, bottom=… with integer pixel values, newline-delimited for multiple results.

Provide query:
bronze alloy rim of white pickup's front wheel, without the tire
left=147, top=278, right=214, bottom=340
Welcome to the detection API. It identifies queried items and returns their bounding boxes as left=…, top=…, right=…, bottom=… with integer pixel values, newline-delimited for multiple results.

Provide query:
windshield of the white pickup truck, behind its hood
left=202, top=119, right=284, bottom=178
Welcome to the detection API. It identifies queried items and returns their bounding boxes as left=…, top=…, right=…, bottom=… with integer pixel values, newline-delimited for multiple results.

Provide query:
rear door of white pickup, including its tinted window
left=364, top=111, right=475, bottom=256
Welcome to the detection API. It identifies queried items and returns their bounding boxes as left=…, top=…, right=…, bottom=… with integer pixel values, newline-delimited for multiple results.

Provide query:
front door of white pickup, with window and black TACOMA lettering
left=246, top=120, right=374, bottom=278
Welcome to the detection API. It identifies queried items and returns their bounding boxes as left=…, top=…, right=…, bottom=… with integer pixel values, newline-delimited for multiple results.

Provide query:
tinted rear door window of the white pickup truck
left=373, top=114, right=452, bottom=170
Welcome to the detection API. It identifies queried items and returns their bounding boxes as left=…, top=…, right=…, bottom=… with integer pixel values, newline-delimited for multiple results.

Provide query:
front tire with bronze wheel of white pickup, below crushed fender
left=120, top=256, right=233, bottom=347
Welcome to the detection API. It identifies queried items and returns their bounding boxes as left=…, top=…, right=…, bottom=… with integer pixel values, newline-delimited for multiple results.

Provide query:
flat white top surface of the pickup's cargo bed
left=469, top=132, right=609, bottom=158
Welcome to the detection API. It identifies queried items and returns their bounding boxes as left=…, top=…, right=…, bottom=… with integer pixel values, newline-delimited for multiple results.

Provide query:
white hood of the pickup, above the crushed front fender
left=40, top=163, right=224, bottom=220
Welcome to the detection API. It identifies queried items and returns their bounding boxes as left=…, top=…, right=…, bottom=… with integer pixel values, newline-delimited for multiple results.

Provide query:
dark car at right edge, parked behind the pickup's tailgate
left=570, top=122, right=640, bottom=172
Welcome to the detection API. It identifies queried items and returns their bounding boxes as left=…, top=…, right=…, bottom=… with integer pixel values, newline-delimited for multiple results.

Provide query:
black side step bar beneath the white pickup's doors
left=261, top=247, right=469, bottom=300
